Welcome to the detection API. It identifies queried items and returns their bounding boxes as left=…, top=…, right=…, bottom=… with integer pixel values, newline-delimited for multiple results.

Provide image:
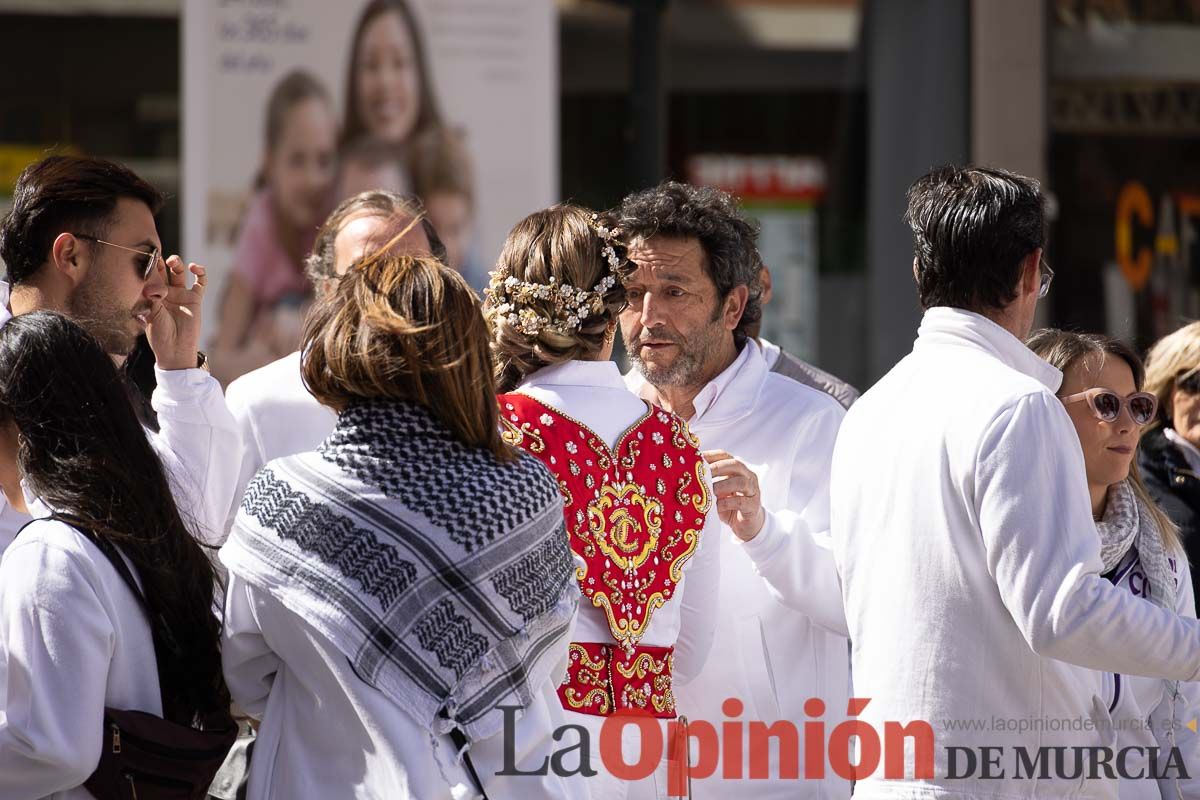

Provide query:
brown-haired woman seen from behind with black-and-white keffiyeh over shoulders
left=221, top=253, right=580, bottom=800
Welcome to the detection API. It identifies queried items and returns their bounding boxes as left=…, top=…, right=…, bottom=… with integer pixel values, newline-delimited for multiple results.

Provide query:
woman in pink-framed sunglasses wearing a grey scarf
left=1028, top=330, right=1200, bottom=800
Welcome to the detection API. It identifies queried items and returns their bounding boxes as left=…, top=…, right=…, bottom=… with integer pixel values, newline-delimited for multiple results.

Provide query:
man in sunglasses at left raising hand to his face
left=0, top=156, right=239, bottom=548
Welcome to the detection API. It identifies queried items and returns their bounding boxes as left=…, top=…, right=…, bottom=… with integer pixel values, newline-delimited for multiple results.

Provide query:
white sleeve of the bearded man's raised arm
left=738, top=402, right=850, bottom=636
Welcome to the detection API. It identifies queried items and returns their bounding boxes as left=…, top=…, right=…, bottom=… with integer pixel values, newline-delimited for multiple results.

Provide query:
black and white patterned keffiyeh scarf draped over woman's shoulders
left=221, top=401, right=580, bottom=741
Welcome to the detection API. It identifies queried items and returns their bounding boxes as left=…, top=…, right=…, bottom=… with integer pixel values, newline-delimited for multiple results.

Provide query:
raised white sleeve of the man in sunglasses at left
left=148, top=367, right=241, bottom=545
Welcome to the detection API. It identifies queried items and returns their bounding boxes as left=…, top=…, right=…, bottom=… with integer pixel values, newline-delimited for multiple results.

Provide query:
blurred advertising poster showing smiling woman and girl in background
left=182, top=0, right=558, bottom=381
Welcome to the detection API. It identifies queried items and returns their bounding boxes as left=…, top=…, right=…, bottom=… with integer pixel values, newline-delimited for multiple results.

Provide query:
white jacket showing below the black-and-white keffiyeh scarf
left=224, top=573, right=587, bottom=800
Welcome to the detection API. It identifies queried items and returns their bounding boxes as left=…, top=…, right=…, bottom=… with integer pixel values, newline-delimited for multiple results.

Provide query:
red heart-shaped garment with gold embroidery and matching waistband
left=499, top=393, right=712, bottom=717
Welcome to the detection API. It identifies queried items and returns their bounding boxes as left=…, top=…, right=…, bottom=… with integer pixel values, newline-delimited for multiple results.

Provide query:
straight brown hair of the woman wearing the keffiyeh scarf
left=301, top=246, right=516, bottom=462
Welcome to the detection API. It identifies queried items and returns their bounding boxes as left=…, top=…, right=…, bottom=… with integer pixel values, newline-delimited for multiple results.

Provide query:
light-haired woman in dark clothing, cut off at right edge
left=1138, top=323, right=1200, bottom=606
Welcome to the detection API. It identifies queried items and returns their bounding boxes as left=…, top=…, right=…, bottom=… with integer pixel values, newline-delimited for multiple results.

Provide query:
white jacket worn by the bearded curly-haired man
left=626, top=341, right=850, bottom=800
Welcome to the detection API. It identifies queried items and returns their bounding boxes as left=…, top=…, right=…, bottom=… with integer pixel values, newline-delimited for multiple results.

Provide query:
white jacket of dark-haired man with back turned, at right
left=832, top=308, right=1200, bottom=799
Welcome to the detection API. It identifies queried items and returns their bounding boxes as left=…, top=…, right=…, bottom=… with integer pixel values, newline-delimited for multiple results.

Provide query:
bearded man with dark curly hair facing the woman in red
left=617, top=182, right=850, bottom=799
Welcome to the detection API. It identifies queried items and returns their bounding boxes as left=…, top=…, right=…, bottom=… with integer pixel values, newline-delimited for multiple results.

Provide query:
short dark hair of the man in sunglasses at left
left=0, top=156, right=163, bottom=283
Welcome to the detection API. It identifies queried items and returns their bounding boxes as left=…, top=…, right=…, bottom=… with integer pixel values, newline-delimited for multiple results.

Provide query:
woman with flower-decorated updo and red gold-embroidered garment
left=484, top=204, right=720, bottom=800
